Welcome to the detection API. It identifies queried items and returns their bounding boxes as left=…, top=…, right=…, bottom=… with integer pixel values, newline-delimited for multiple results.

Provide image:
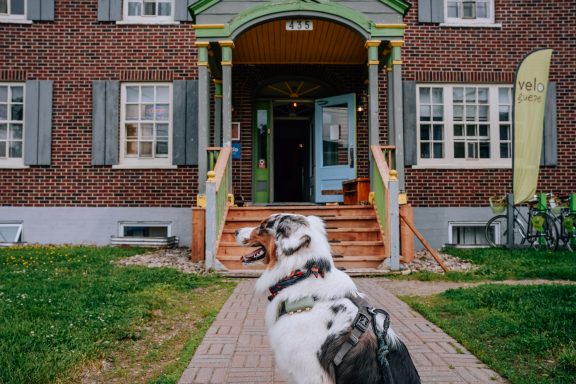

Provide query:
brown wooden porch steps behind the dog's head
left=216, top=205, right=386, bottom=271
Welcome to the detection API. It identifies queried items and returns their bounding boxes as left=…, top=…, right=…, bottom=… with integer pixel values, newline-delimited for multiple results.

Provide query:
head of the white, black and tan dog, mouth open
left=236, top=213, right=328, bottom=268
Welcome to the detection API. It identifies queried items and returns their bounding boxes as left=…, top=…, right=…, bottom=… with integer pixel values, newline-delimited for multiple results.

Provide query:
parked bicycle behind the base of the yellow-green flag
left=484, top=193, right=558, bottom=250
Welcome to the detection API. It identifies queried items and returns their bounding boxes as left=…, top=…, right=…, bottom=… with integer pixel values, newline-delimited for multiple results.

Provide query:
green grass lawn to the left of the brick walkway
left=0, top=246, right=234, bottom=384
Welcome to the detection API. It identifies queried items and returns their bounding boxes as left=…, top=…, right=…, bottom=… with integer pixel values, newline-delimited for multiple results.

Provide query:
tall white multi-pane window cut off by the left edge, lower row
left=0, top=83, right=24, bottom=166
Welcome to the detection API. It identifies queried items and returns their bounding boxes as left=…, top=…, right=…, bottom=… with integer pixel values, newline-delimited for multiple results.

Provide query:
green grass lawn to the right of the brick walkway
left=402, top=249, right=576, bottom=384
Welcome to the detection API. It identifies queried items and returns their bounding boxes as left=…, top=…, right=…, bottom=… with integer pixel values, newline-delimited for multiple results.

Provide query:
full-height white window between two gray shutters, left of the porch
left=120, top=83, right=172, bottom=166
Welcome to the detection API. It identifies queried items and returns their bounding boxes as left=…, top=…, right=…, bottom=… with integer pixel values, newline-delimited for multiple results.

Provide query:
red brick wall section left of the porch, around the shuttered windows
left=0, top=0, right=197, bottom=207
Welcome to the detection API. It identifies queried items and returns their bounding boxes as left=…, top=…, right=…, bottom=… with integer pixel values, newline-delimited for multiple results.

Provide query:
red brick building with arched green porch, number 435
left=0, top=0, right=576, bottom=247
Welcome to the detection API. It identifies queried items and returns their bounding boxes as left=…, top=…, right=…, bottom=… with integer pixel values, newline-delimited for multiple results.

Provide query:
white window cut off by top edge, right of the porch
left=445, top=0, right=494, bottom=24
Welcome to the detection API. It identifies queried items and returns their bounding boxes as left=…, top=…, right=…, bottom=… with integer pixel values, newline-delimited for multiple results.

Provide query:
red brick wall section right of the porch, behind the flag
left=402, top=0, right=576, bottom=206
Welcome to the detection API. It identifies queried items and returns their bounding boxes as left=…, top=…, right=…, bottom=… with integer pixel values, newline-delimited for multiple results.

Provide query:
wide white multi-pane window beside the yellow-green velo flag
left=417, top=84, right=512, bottom=168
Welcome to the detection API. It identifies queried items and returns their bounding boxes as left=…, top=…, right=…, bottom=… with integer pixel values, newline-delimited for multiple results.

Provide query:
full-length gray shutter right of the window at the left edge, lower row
left=24, top=80, right=53, bottom=165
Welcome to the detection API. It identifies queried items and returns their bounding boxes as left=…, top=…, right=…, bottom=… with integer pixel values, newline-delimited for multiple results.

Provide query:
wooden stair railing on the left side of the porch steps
left=205, top=147, right=232, bottom=270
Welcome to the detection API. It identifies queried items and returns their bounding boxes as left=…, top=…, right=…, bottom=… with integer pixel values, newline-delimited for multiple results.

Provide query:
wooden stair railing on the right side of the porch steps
left=370, top=145, right=400, bottom=271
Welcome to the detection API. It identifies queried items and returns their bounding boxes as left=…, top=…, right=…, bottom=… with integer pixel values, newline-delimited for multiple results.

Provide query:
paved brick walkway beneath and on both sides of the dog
left=179, top=278, right=505, bottom=384
